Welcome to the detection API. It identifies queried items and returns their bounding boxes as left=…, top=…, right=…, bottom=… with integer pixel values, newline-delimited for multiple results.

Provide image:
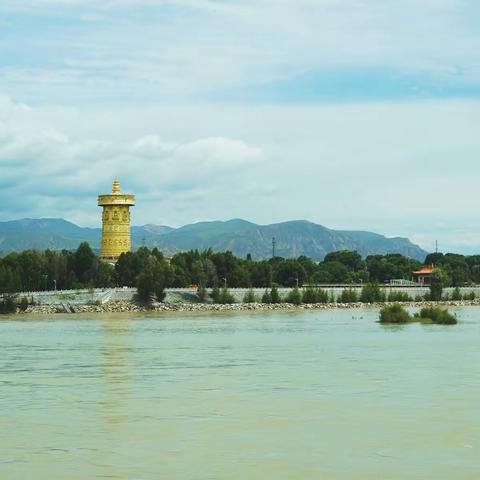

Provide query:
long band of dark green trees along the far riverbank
left=0, top=243, right=480, bottom=297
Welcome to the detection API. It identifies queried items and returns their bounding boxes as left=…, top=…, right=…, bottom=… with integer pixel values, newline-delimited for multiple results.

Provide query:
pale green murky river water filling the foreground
left=0, top=307, right=480, bottom=480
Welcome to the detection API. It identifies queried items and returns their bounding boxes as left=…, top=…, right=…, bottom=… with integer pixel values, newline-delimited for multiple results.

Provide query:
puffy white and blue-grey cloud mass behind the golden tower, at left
left=0, top=101, right=264, bottom=229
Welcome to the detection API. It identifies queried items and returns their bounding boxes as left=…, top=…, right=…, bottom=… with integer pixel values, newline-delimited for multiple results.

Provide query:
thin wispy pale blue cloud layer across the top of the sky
left=0, top=0, right=480, bottom=103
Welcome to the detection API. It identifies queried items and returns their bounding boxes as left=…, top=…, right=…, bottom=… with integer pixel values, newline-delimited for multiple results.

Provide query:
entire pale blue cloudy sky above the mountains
left=0, top=0, right=480, bottom=254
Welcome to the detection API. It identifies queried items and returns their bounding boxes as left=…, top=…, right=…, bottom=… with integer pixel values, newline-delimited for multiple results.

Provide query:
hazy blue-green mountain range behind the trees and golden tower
left=0, top=218, right=427, bottom=261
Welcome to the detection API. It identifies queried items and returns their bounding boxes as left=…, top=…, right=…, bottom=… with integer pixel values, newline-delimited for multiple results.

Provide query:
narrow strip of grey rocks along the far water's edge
left=17, top=300, right=480, bottom=315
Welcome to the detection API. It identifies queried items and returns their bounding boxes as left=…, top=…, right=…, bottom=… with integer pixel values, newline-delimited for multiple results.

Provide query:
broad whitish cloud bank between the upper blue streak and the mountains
left=0, top=95, right=480, bottom=255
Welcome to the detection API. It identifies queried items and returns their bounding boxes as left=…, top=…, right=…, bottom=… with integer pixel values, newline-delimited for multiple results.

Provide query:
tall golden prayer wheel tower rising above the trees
left=98, top=179, right=135, bottom=262
